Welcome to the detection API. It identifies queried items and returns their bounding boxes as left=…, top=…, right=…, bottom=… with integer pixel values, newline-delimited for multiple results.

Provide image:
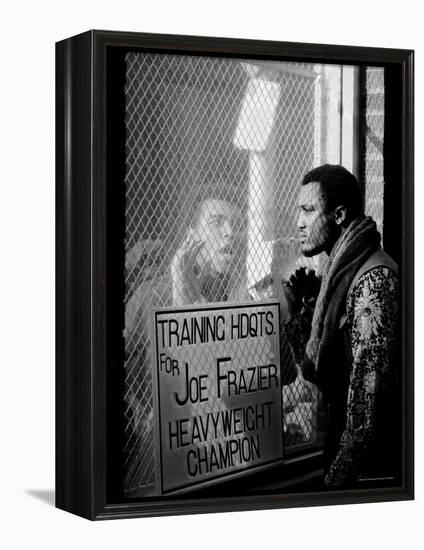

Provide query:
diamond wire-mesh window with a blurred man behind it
left=124, top=53, right=380, bottom=494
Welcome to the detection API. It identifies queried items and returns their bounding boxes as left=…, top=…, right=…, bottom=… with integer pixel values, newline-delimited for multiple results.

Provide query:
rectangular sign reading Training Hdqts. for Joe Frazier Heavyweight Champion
left=154, top=302, right=283, bottom=493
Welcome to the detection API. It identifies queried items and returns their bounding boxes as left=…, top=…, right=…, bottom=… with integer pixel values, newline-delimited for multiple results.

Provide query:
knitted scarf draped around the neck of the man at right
left=302, top=216, right=380, bottom=387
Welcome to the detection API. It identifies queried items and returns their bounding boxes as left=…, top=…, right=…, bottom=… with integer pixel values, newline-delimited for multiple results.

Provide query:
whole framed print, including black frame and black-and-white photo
left=56, top=31, right=413, bottom=519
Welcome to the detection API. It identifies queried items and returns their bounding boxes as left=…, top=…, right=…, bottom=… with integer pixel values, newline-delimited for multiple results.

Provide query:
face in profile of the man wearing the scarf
left=297, top=181, right=338, bottom=257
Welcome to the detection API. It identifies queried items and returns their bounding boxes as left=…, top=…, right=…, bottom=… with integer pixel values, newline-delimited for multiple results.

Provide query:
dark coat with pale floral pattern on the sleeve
left=287, top=250, right=401, bottom=488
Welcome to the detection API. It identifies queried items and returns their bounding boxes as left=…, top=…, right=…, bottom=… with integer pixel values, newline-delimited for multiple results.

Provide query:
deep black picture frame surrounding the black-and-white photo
left=56, top=31, right=414, bottom=520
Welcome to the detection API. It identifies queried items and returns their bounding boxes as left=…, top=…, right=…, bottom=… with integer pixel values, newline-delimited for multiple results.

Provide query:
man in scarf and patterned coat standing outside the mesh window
left=285, top=164, right=400, bottom=488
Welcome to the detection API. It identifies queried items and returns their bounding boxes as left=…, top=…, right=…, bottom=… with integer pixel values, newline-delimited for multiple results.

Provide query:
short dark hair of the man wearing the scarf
left=302, top=164, right=364, bottom=220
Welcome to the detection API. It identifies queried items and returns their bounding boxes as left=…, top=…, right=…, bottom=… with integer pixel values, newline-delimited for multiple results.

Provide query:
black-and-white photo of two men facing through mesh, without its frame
left=113, top=52, right=408, bottom=497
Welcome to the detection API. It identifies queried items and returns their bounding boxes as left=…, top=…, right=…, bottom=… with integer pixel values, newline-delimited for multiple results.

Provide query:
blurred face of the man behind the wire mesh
left=194, top=199, right=238, bottom=273
